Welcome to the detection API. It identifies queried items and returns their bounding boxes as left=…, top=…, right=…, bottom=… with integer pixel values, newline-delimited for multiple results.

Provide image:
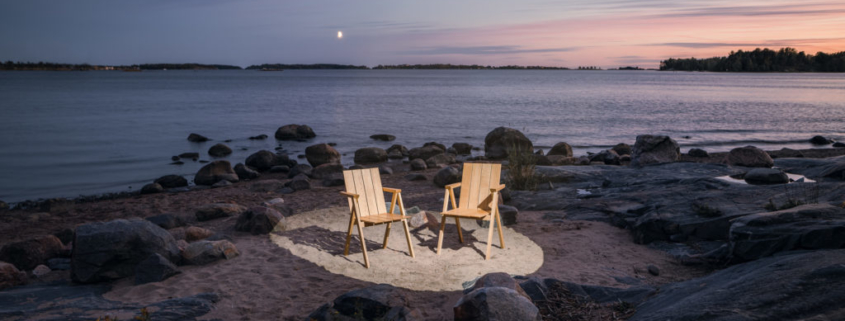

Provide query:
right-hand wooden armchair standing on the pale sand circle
left=437, top=163, right=505, bottom=260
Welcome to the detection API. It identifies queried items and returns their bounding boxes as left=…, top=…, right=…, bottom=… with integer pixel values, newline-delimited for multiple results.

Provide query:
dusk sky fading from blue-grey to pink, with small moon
left=0, top=0, right=845, bottom=68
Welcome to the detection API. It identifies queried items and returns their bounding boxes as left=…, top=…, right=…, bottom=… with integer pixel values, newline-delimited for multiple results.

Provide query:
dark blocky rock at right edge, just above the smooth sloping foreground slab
left=730, top=204, right=845, bottom=262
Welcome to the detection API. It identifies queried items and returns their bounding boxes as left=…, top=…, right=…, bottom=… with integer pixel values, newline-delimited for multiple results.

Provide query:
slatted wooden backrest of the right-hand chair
left=459, top=163, right=502, bottom=210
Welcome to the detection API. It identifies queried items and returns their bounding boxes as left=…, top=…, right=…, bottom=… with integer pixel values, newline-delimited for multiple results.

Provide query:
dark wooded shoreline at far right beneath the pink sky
left=660, top=47, right=845, bottom=72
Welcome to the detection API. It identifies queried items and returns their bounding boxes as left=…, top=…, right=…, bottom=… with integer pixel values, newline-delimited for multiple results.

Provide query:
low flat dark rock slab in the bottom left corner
left=0, top=281, right=220, bottom=321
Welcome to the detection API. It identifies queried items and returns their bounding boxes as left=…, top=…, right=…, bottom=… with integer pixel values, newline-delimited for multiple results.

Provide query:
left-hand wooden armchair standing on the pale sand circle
left=340, top=168, right=414, bottom=268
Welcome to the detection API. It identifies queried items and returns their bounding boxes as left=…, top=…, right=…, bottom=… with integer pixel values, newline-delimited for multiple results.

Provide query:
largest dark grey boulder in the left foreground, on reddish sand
left=71, top=219, right=180, bottom=283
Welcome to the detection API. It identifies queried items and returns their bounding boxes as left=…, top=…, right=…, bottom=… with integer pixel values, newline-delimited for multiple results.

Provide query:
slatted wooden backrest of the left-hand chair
left=343, top=168, right=387, bottom=217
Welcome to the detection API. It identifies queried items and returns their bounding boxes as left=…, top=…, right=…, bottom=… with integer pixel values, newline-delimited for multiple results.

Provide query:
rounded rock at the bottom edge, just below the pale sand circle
left=454, top=287, right=542, bottom=321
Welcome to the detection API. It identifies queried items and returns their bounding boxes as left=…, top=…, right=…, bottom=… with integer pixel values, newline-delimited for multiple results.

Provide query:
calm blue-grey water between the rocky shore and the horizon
left=0, top=70, right=845, bottom=202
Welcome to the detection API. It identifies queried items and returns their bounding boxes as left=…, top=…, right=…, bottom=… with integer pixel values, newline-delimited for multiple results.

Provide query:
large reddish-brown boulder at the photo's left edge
left=0, top=235, right=64, bottom=271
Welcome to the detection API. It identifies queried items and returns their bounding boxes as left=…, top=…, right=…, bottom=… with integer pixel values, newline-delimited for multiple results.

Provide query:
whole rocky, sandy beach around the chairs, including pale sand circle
left=0, top=125, right=845, bottom=320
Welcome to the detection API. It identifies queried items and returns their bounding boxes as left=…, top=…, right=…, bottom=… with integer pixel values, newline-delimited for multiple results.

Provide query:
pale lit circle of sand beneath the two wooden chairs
left=270, top=207, right=543, bottom=291
